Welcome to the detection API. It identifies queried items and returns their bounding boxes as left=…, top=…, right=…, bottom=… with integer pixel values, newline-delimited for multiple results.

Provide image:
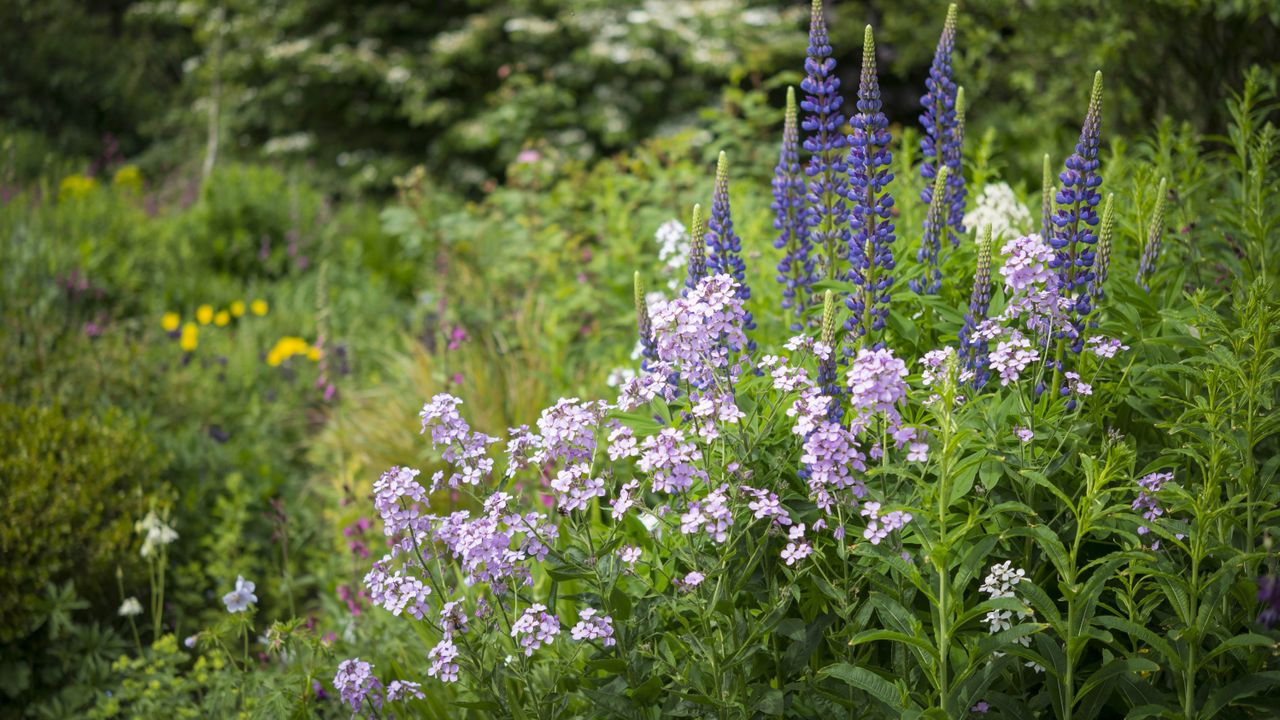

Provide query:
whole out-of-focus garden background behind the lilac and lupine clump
left=0, top=0, right=1280, bottom=717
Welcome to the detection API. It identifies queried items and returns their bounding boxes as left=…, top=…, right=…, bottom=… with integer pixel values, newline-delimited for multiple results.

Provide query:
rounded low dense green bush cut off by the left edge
left=0, top=402, right=159, bottom=642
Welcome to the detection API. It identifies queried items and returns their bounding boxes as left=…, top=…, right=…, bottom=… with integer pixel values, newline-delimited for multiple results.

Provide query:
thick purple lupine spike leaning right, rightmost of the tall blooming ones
left=1050, top=72, right=1102, bottom=354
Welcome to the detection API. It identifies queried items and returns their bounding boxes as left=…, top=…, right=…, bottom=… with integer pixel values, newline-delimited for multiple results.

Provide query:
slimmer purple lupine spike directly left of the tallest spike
left=773, top=87, right=815, bottom=331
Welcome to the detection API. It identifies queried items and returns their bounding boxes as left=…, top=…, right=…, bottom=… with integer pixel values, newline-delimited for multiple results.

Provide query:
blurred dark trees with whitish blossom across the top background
left=0, top=0, right=1280, bottom=190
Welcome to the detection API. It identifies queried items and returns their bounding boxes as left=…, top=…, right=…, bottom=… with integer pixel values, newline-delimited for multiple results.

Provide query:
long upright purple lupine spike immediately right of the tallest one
left=845, top=26, right=895, bottom=346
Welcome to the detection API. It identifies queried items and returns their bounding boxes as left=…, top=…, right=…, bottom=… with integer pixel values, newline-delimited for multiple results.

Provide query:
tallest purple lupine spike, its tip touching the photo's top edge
left=800, top=0, right=849, bottom=279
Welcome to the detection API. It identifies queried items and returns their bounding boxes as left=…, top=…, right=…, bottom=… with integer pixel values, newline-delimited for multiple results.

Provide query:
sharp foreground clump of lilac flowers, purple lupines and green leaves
left=333, top=7, right=1280, bottom=717
